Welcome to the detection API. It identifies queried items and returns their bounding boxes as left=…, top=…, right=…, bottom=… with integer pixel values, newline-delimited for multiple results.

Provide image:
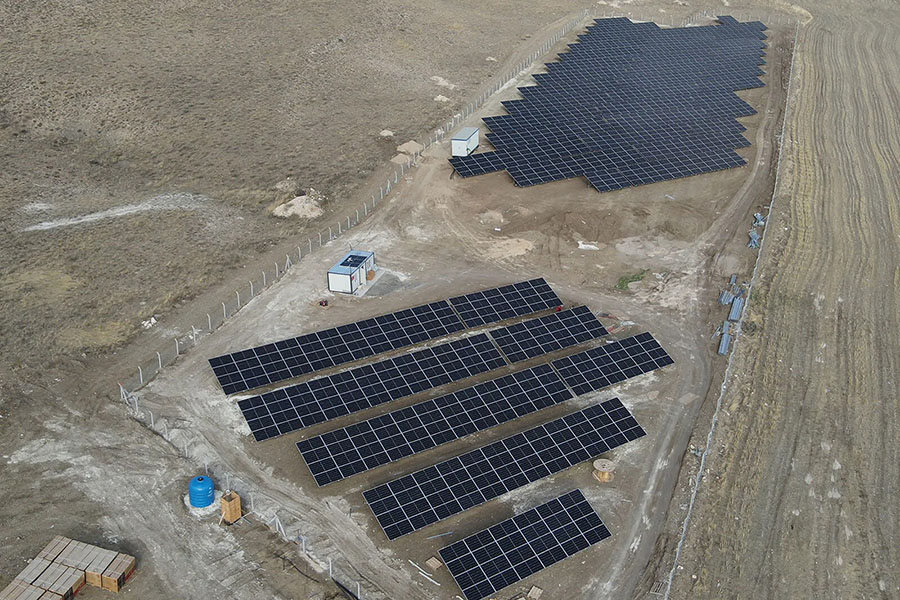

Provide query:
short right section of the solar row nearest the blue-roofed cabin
left=450, top=278, right=562, bottom=327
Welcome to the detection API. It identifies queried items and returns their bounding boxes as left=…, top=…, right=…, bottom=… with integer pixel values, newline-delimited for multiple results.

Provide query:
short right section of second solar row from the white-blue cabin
left=490, top=306, right=607, bottom=363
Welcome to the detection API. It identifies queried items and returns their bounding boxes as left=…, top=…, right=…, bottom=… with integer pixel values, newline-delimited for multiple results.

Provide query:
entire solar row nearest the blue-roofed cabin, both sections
left=209, top=279, right=562, bottom=394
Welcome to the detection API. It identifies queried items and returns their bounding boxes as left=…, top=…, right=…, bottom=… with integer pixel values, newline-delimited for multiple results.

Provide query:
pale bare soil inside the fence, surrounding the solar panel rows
left=3, top=17, right=784, bottom=598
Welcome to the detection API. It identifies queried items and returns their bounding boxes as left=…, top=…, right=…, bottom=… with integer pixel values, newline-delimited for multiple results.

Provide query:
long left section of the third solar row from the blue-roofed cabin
left=297, top=365, right=572, bottom=486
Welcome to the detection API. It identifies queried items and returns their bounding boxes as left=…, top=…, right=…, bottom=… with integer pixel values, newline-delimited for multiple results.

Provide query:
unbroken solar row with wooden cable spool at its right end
left=363, top=398, right=645, bottom=540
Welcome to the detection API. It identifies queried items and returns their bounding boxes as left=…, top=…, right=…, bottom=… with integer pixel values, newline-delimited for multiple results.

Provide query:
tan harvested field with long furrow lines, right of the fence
left=652, top=3, right=900, bottom=599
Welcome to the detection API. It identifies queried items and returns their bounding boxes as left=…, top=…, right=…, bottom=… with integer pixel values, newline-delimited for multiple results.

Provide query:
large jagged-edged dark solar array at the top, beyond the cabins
left=450, top=17, right=766, bottom=191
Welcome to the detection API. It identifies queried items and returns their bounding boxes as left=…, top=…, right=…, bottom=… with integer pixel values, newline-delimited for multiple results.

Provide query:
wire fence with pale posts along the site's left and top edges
left=119, top=9, right=795, bottom=598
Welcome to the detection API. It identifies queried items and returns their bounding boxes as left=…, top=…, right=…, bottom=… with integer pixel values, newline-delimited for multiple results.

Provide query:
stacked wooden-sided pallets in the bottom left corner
left=0, top=535, right=135, bottom=600
